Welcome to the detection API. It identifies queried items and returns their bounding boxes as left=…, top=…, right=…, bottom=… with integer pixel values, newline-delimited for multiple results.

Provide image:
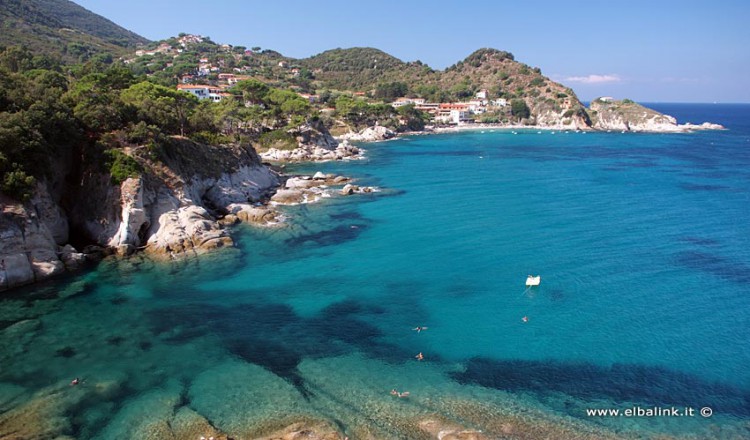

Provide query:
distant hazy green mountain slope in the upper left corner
left=0, top=0, right=148, bottom=62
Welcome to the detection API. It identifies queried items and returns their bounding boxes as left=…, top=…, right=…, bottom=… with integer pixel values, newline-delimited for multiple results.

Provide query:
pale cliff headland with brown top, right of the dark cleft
left=71, top=138, right=279, bottom=257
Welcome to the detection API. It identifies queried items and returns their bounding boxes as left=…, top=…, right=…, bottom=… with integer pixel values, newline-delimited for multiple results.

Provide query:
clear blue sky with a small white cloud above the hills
left=74, top=0, right=750, bottom=103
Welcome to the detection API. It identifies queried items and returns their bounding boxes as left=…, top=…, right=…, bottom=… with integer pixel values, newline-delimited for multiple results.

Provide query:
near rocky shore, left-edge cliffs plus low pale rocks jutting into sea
left=0, top=127, right=379, bottom=291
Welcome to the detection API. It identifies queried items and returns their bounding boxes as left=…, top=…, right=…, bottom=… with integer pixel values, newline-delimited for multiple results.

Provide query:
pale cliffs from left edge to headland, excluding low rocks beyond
left=0, top=138, right=279, bottom=290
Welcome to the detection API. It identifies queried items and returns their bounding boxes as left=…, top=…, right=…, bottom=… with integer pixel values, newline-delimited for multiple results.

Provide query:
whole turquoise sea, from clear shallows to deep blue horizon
left=0, top=104, right=750, bottom=439
